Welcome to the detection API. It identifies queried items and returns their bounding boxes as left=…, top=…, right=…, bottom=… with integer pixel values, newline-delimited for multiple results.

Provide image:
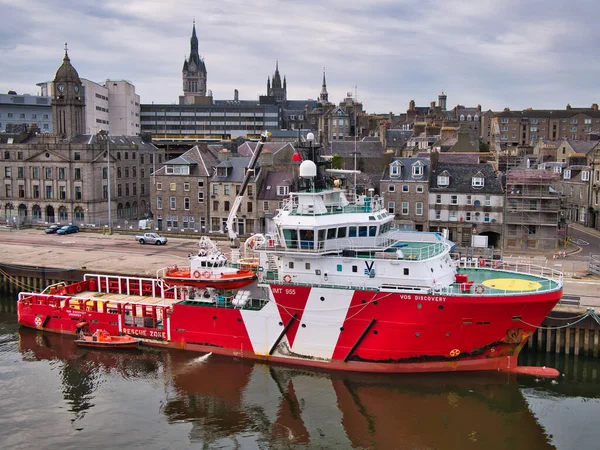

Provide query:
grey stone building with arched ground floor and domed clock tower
left=0, top=51, right=163, bottom=227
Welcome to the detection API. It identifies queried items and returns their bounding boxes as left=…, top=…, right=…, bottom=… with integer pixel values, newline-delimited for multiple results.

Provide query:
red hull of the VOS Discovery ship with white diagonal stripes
left=18, top=277, right=562, bottom=372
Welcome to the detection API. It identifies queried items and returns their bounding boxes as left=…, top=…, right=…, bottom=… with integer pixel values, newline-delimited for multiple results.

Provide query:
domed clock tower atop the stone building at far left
left=52, top=44, right=85, bottom=138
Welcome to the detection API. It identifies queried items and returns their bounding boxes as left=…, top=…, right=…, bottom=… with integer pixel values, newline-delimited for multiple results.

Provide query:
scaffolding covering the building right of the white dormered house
left=504, top=169, right=566, bottom=251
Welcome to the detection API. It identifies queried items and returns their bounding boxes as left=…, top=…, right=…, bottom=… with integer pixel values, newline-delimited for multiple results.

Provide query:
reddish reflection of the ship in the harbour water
left=18, top=328, right=554, bottom=449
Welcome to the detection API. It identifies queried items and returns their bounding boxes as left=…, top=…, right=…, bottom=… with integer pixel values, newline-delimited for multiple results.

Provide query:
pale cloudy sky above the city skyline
left=0, top=0, right=600, bottom=114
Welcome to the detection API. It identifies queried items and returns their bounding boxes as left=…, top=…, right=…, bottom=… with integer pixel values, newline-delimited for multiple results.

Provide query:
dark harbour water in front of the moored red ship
left=0, top=298, right=600, bottom=450
